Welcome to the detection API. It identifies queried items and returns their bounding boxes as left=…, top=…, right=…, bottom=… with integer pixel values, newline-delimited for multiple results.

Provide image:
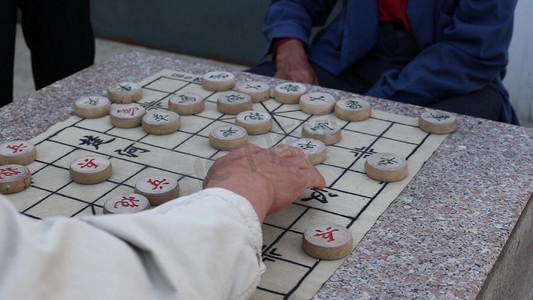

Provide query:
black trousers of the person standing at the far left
left=0, top=0, right=94, bottom=106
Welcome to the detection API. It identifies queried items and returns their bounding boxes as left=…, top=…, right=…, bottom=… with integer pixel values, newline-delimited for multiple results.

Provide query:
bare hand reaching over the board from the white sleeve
left=204, top=144, right=326, bottom=223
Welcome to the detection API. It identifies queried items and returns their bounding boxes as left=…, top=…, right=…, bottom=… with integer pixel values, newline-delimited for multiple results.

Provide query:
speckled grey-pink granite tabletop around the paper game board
left=0, top=52, right=533, bottom=299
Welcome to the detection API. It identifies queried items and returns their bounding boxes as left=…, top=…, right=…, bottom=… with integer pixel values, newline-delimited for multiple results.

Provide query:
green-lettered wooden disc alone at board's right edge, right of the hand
left=365, top=153, right=409, bottom=182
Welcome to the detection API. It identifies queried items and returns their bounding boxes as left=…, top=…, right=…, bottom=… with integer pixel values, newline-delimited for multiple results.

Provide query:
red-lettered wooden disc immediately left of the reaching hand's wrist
left=134, top=175, right=180, bottom=205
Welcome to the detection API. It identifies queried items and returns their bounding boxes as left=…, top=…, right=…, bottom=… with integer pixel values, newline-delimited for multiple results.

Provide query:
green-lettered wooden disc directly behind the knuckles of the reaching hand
left=209, top=125, right=248, bottom=150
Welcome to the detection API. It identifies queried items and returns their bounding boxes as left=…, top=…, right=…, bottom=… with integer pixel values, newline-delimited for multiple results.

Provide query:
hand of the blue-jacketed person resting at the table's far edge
left=274, top=40, right=318, bottom=85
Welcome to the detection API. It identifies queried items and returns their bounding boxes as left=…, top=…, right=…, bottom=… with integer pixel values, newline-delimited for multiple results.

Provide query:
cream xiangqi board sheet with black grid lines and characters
left=2, top=70, right=446, bottom=299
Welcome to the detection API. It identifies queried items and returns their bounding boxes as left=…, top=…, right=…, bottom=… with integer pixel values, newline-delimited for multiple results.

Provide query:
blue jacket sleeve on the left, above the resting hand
left=263, top=0, right=337, bottom=51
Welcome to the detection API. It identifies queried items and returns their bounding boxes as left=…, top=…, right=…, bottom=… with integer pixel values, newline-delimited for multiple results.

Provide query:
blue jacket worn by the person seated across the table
left=264, top=0, right=518, bottom=124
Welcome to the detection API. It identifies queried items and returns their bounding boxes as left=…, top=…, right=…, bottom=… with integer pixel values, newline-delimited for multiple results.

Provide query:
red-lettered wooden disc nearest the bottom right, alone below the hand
left=302, top=224, right=353, bottom=260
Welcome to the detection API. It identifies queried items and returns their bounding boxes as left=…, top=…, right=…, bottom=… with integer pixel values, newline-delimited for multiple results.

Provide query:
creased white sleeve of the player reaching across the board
left=0, top=189, right=265, bottom=299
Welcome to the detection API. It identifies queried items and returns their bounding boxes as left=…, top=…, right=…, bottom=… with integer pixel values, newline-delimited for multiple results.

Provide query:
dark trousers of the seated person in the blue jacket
left=247, top=23, right=503, bottom=121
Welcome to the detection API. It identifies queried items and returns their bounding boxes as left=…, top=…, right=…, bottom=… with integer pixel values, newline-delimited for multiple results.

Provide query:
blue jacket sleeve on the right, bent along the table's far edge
left=368, top=0, right=516, bottom=105
